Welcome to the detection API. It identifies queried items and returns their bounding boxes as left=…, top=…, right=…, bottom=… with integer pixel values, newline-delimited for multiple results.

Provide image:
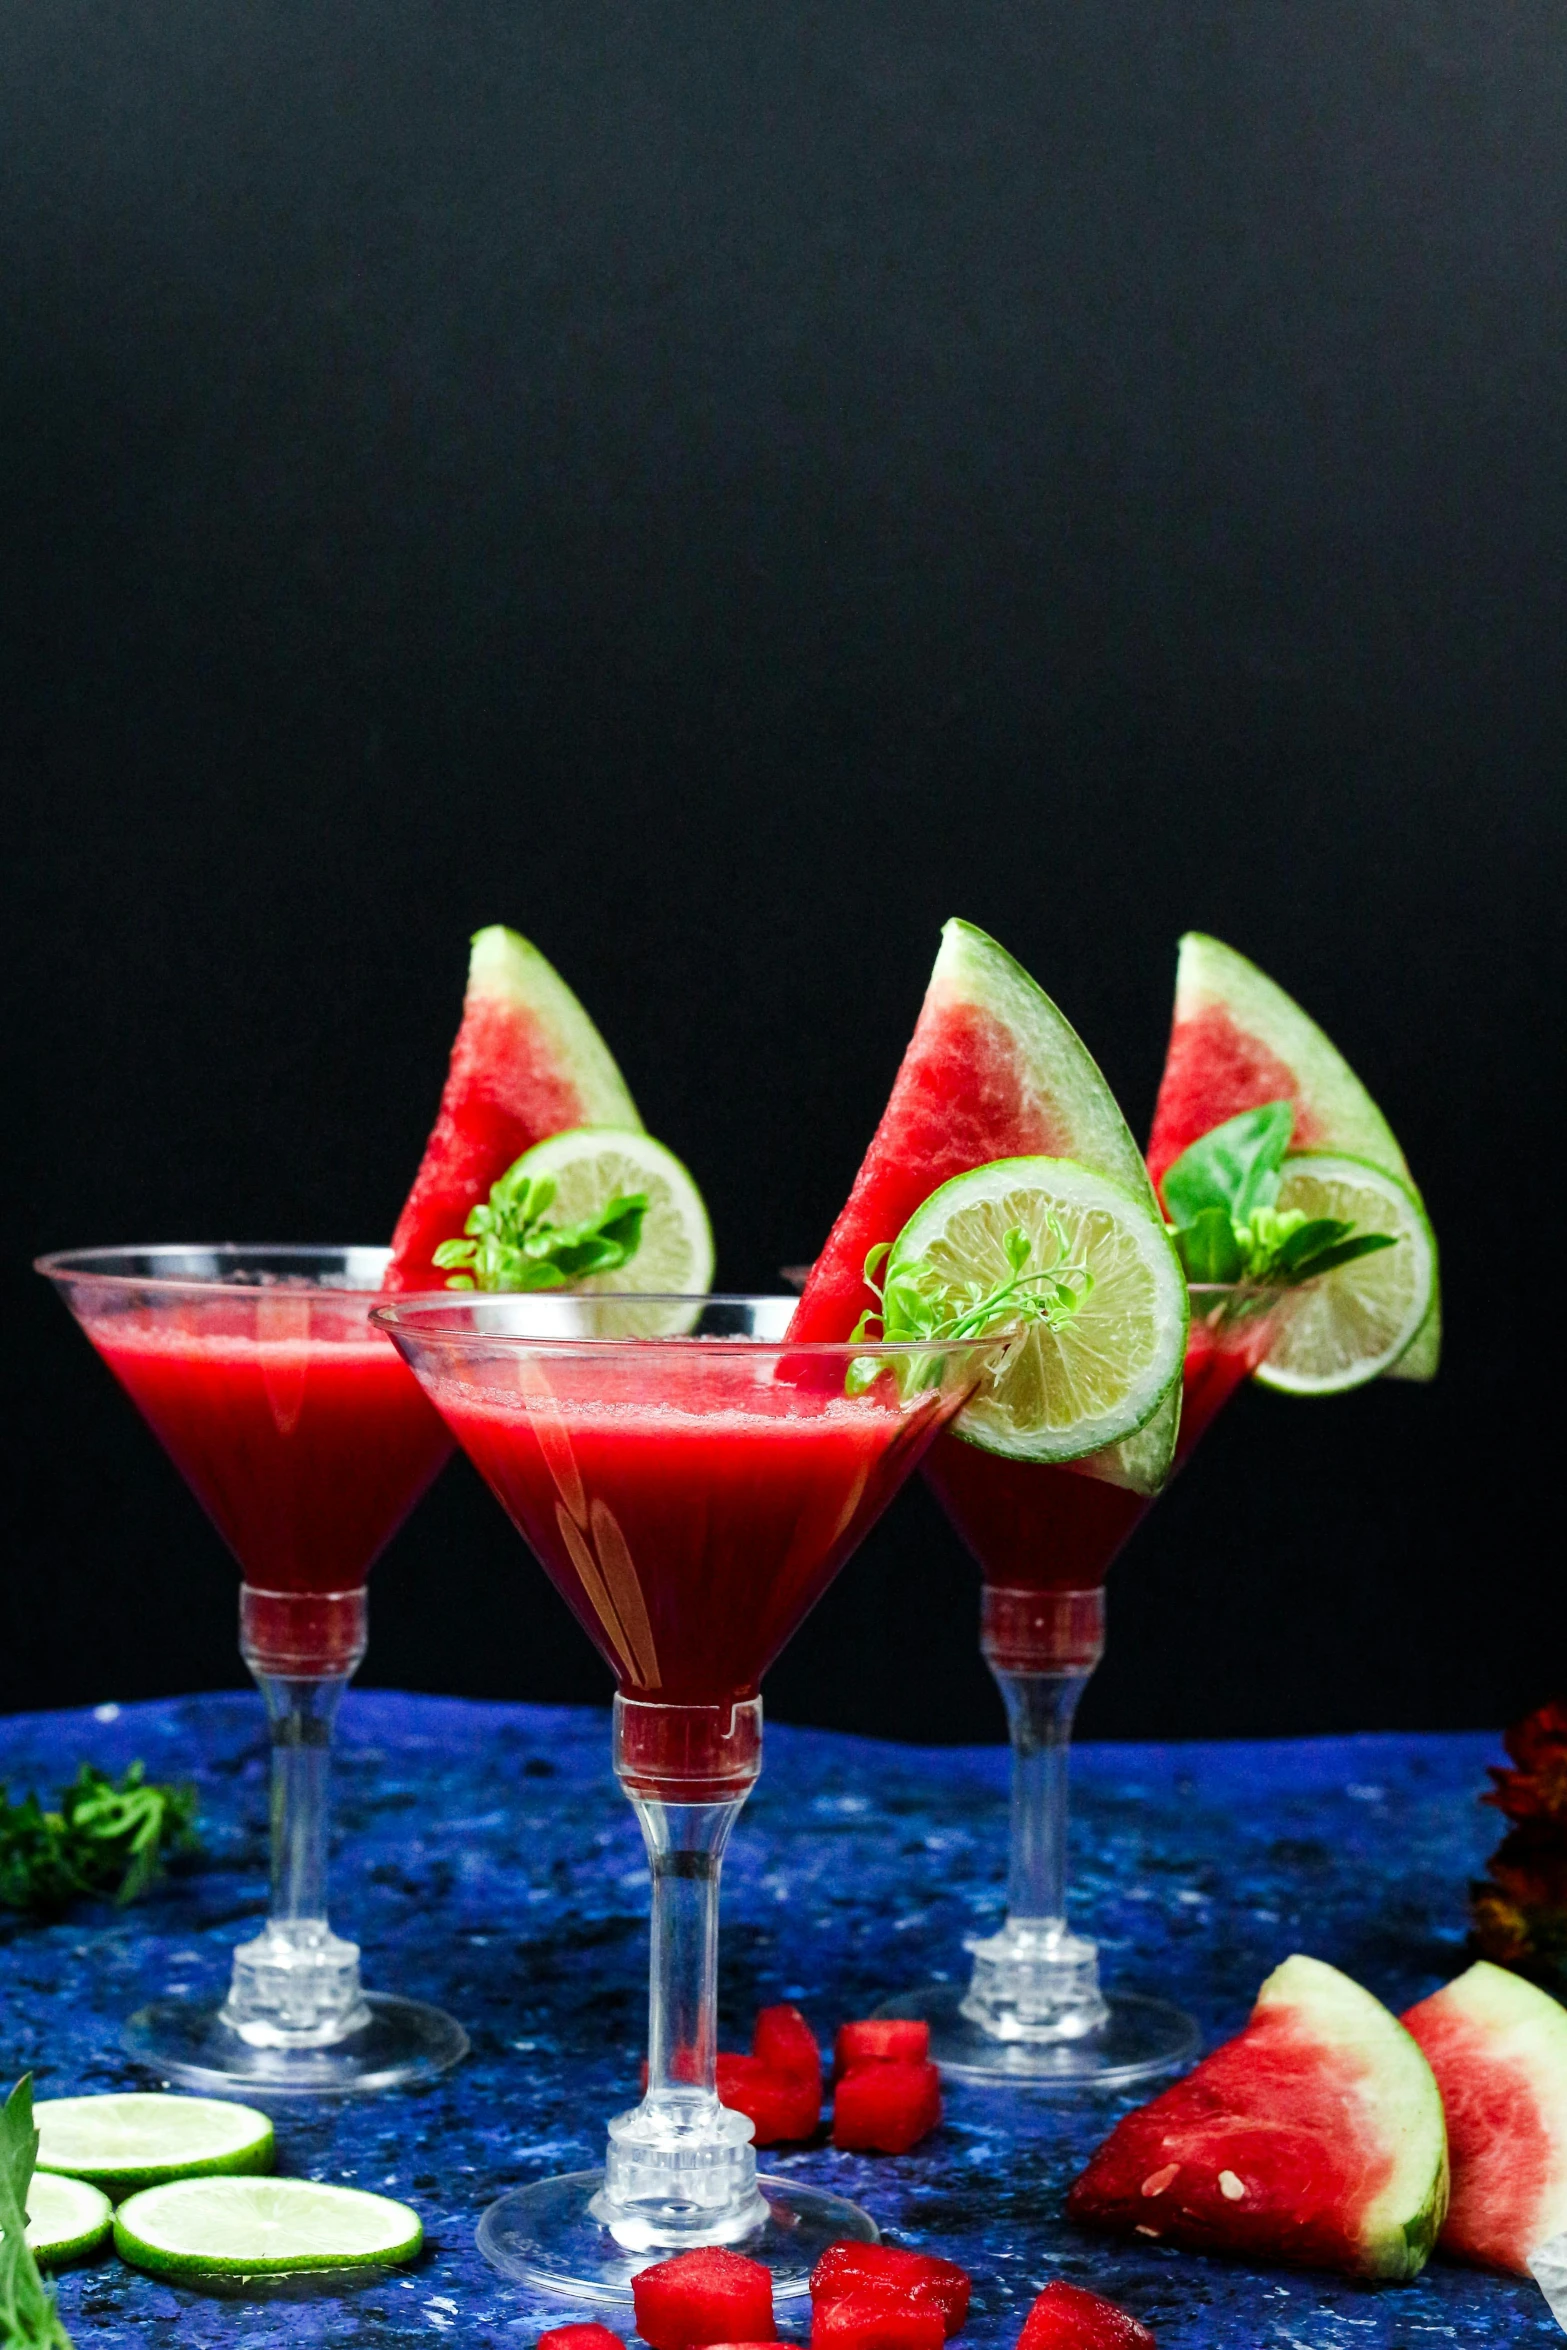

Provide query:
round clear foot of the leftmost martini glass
left=120, top=1990, right=468, bottom=2096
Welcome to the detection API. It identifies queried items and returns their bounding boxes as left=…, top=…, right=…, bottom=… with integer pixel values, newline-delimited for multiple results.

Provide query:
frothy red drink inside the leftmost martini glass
left=85, top=1290, right=451, bottom=1671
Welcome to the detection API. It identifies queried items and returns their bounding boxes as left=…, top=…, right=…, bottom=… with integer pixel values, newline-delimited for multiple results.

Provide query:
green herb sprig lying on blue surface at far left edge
left=0, top=1763, right=195, bottom=1918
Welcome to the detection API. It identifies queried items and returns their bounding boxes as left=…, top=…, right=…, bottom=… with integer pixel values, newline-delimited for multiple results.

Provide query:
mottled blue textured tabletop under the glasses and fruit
left=0, top=1692, right=1562, bottom=2350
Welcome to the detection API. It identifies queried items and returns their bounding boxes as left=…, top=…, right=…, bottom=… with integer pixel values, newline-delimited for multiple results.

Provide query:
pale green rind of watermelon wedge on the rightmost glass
left=1149, top=931, right=1442, bottom=1379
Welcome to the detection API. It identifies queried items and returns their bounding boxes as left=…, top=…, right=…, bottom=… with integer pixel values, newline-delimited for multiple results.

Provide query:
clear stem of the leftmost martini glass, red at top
left=223, top=1589, right=369, bottom=2047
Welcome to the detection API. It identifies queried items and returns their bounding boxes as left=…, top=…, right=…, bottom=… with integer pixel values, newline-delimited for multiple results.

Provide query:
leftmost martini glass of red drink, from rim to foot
left=38, top=1248, right=468, bottom=2096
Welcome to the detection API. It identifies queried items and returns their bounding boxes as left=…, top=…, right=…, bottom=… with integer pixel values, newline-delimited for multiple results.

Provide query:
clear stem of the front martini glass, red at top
left=592, top=1697, right=766, bottom=2251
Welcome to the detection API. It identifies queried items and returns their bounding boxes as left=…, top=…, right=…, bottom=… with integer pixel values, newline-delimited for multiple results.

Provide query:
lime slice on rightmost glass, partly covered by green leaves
left=1255, top=1152, right=1435, bottom=1396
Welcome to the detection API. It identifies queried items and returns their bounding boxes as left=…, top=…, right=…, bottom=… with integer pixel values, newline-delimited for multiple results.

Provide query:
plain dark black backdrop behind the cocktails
left=0, top=0, right=1567, bottom=1737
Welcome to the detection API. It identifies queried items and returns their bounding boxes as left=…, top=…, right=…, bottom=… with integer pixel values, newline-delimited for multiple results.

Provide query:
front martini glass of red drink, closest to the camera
left=374, top=1295, right=1006, bottom=2303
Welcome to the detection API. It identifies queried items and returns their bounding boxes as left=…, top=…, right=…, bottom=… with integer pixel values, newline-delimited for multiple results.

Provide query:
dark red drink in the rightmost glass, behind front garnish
left=926, top=1314, right=1271, bottom=1591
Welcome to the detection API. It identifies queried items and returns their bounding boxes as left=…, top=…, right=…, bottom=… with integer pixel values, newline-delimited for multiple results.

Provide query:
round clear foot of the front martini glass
left=479, top=2171, right=879, bottom=2305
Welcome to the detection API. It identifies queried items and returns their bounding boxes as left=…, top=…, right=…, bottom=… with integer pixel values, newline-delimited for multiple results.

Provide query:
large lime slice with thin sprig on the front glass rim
left=890, top=1159, right=1186, bottom=1481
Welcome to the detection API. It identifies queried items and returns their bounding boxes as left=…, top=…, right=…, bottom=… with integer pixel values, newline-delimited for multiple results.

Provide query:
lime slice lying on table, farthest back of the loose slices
left=33, top=2094, right=273, bottom=2202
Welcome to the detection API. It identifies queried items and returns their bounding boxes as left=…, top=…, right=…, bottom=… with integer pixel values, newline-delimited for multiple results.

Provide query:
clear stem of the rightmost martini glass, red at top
left=963, top=1586, right=1109, bottom=2040
